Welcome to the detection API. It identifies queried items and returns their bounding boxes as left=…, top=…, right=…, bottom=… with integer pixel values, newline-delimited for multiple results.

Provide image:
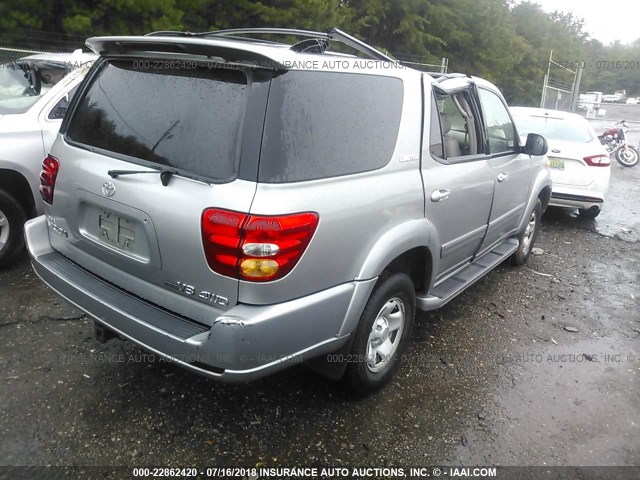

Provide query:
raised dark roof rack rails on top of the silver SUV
left=147, top=27, right=395, bottom=62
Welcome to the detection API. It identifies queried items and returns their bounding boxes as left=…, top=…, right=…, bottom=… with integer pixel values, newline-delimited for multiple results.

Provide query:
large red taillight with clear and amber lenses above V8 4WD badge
left=201, top=208, right=318, bottom=282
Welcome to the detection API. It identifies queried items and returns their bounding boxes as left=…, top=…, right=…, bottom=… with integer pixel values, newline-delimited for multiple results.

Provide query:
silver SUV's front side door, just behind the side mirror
left=478, top=87, right=533, bottom=250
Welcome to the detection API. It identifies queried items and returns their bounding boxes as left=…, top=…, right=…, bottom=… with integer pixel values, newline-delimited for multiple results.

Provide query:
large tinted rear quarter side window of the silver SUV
left=259, top=71, right=403, bottom=183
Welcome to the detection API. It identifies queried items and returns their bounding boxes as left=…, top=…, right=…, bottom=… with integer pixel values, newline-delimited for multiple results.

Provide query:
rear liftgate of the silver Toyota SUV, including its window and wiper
left=50, top=58, right=268, bottom=323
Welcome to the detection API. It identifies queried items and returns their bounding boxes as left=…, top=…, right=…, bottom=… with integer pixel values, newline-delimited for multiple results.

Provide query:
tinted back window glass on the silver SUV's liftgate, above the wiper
left=67, top=61, right=247, bottom=180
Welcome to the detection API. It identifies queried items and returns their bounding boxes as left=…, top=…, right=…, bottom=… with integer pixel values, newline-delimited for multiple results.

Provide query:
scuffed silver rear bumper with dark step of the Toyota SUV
left=25, top=216, right=375, bottom=382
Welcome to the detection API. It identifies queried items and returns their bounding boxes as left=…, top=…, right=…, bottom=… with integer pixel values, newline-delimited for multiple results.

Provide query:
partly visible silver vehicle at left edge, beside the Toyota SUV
left=0, top=50, right=97, bottom=268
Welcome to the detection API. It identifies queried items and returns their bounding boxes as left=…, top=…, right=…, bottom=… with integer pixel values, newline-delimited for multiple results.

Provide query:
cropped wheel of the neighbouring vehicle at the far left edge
left=0, top=190, right=27, bottom=268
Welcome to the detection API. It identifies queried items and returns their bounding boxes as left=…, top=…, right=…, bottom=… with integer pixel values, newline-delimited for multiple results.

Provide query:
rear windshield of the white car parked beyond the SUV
left=514, top=115, right=593, bottom=143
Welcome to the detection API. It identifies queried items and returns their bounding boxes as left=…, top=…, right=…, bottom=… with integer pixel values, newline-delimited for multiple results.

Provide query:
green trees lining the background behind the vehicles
left=0, top=0, right=640, bottom=100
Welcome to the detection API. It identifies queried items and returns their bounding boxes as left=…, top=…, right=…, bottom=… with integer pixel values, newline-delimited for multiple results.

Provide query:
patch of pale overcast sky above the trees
left=533, top=0, right=640, bottom=45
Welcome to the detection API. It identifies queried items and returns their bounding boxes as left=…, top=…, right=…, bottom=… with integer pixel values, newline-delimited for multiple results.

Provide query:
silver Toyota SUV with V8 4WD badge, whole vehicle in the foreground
left=26, top=29, right=551, bottom=394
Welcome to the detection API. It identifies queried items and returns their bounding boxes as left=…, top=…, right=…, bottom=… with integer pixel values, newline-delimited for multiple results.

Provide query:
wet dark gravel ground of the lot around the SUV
left=0, top=123, right=640, bottom=472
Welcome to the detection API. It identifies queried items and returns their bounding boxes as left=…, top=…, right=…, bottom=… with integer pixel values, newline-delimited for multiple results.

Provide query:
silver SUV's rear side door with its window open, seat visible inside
left=422, top=81, right=494, bottom=283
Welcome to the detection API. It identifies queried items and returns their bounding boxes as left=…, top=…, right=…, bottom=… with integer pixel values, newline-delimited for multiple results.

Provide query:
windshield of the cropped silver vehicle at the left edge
left=0, top=59, right=70, bottom=115
